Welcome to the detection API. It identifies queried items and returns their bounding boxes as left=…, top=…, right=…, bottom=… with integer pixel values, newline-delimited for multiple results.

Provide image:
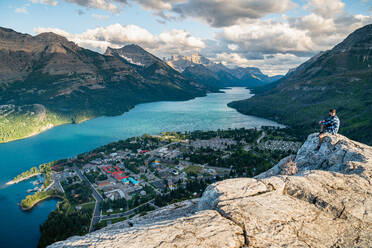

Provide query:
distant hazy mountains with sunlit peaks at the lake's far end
left=164, top=54, right=282, bottom=88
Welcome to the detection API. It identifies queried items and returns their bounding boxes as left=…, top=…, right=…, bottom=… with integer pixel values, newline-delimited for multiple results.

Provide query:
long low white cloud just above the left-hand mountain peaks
left=34, top=24, right=205, bottom=57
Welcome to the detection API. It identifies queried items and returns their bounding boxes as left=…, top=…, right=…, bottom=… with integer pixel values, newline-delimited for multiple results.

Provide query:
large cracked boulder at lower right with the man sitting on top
left=199, top=134, right=372, bottom=247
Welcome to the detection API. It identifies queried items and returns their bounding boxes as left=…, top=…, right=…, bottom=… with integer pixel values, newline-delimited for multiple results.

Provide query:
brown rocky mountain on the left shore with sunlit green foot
left=0, top=28, right=209, bottom=142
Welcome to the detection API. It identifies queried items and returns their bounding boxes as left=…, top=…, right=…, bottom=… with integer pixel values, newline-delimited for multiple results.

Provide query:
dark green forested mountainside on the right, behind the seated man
left=229, top=25, right=372, bottom=144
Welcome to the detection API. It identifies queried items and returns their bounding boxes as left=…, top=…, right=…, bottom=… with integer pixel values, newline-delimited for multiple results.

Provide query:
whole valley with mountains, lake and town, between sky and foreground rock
left=0, top=20, right=372, bottom=247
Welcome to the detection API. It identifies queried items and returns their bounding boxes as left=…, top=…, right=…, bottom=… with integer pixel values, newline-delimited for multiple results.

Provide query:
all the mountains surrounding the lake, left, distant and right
left=5, top=25, right=372, bottom=144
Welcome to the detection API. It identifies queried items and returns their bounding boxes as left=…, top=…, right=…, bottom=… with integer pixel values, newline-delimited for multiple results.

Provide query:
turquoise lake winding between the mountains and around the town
left=0, top=87, right=279, bottom=248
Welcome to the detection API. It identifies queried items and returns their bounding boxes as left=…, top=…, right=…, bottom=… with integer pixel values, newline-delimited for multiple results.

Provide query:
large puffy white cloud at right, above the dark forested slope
left=216, top=8, right=372, bottom=58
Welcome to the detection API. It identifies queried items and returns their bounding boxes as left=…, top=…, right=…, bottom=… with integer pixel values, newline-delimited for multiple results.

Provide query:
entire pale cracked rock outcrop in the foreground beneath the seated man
left=51, top=134, right=372, bottom=247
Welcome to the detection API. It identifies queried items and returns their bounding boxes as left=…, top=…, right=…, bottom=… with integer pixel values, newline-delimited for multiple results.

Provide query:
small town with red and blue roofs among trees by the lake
left=11, top=127, right=301, bottom=246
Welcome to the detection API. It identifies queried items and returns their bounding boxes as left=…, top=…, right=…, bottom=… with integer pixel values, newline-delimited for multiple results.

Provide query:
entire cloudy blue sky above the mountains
left=0, top=0, right=372, bottom=76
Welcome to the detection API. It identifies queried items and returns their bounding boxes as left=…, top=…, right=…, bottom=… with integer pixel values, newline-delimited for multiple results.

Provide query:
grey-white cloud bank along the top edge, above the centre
left=56, top=0, right=297, bottom=27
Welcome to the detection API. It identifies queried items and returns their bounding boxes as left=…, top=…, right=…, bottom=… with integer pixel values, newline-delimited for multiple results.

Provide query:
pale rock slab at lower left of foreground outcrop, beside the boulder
left=50, top=200, right=244, bottom=248
